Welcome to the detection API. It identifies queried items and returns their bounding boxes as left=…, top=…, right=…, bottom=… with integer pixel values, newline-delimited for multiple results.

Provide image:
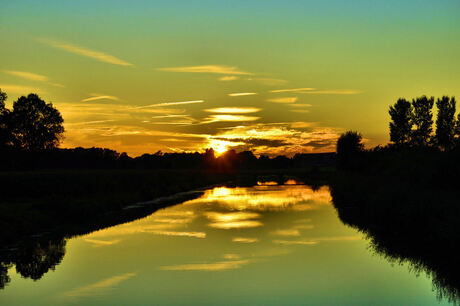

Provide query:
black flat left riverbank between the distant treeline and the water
left=0, top=168, right=333, bottom=246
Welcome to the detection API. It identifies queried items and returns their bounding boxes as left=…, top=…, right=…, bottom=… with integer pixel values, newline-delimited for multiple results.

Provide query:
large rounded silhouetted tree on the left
left=11, top=94, right=64, bottom=151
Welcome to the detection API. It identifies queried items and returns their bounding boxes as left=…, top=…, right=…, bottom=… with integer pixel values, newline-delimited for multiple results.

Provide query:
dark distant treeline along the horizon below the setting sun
left=0, top=147, right=336, bottom=171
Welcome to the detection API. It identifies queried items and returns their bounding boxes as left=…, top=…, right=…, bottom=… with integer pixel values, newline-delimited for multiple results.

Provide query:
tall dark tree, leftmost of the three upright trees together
left=388, top=98, right=412, bottom=146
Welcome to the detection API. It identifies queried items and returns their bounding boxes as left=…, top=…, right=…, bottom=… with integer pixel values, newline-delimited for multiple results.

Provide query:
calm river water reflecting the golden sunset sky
left=0, top=185, right=447, bottom=305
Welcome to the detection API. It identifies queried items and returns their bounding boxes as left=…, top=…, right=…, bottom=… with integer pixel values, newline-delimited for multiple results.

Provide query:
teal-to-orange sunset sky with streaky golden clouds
left=0, top=0, right=460, bottom=156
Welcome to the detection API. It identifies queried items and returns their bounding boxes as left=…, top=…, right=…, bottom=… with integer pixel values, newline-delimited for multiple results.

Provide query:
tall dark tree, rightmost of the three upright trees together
left=436, top=96, right=455, bottom=150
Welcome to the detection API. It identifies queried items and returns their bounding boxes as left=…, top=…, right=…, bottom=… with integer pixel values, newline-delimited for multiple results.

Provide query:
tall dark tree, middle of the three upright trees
left=411, top=96, right=434, bottom=147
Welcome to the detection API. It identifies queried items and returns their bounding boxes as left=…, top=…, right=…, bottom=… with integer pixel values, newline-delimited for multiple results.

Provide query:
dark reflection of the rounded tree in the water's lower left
left=0, top=239, right=66, bottom=289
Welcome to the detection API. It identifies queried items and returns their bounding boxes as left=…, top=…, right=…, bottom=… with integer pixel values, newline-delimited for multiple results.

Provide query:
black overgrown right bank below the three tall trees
left=331, top=148, right=460, bottom=301
